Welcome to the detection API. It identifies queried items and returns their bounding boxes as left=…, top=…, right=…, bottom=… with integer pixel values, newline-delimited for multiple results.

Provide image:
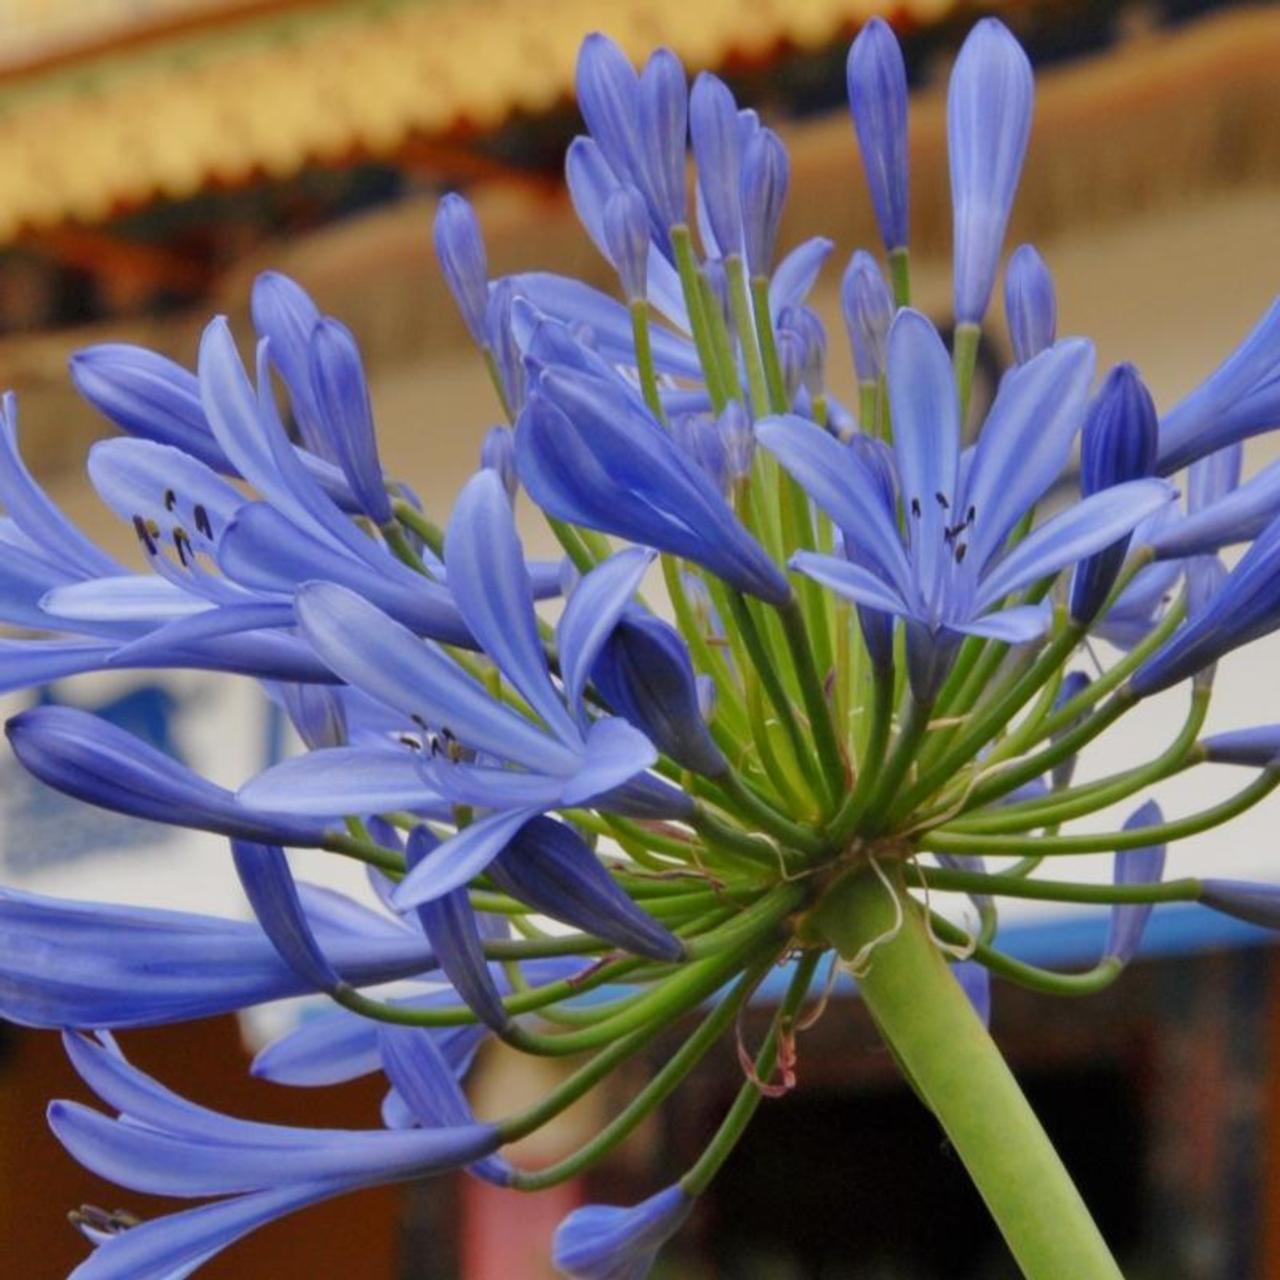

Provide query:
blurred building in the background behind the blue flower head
left=0, top=0, right=1280, bottom=1280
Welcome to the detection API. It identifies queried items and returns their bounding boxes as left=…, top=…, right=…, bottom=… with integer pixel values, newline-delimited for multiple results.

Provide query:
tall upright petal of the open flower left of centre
left=444, top=471, right=582, bottom=749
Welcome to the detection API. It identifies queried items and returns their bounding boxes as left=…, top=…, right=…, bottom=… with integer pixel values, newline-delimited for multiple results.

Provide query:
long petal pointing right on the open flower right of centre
left=975, top=480, right=1176, bottom=612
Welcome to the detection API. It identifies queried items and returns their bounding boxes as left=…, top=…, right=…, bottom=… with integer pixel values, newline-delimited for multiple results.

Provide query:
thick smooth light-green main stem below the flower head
left=814, top=870, right=1121, bottom=1280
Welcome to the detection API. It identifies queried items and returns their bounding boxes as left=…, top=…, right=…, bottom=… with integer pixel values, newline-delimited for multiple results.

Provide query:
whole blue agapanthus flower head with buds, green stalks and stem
left=0, top=19, right=1280, bottom=1280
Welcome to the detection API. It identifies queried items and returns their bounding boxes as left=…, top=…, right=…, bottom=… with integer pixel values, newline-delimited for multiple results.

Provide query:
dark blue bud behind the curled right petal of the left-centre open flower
left=591, top=613, right=728, bottom=777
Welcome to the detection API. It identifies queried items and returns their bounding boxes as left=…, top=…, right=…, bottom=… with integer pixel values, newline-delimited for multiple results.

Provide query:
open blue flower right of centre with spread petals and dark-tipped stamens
left=758, top=310, right=1172, bottom=700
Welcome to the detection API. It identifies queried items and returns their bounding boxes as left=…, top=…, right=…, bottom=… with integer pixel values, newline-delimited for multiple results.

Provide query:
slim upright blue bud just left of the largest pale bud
left=846, top=18, right=910, bottom=252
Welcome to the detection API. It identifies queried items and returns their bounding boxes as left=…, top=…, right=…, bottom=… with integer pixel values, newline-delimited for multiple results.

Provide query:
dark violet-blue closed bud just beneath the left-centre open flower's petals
left=489, top=818, right=685, bottom=964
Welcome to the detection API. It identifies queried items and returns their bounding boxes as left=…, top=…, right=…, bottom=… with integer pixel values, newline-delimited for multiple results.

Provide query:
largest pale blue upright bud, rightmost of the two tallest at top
left=947, top=18, right=1034, bottom=324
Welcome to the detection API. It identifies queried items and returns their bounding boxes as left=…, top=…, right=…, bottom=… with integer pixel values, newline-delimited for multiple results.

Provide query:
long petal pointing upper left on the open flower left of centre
left=294, top=582, right=579, bottom=773
